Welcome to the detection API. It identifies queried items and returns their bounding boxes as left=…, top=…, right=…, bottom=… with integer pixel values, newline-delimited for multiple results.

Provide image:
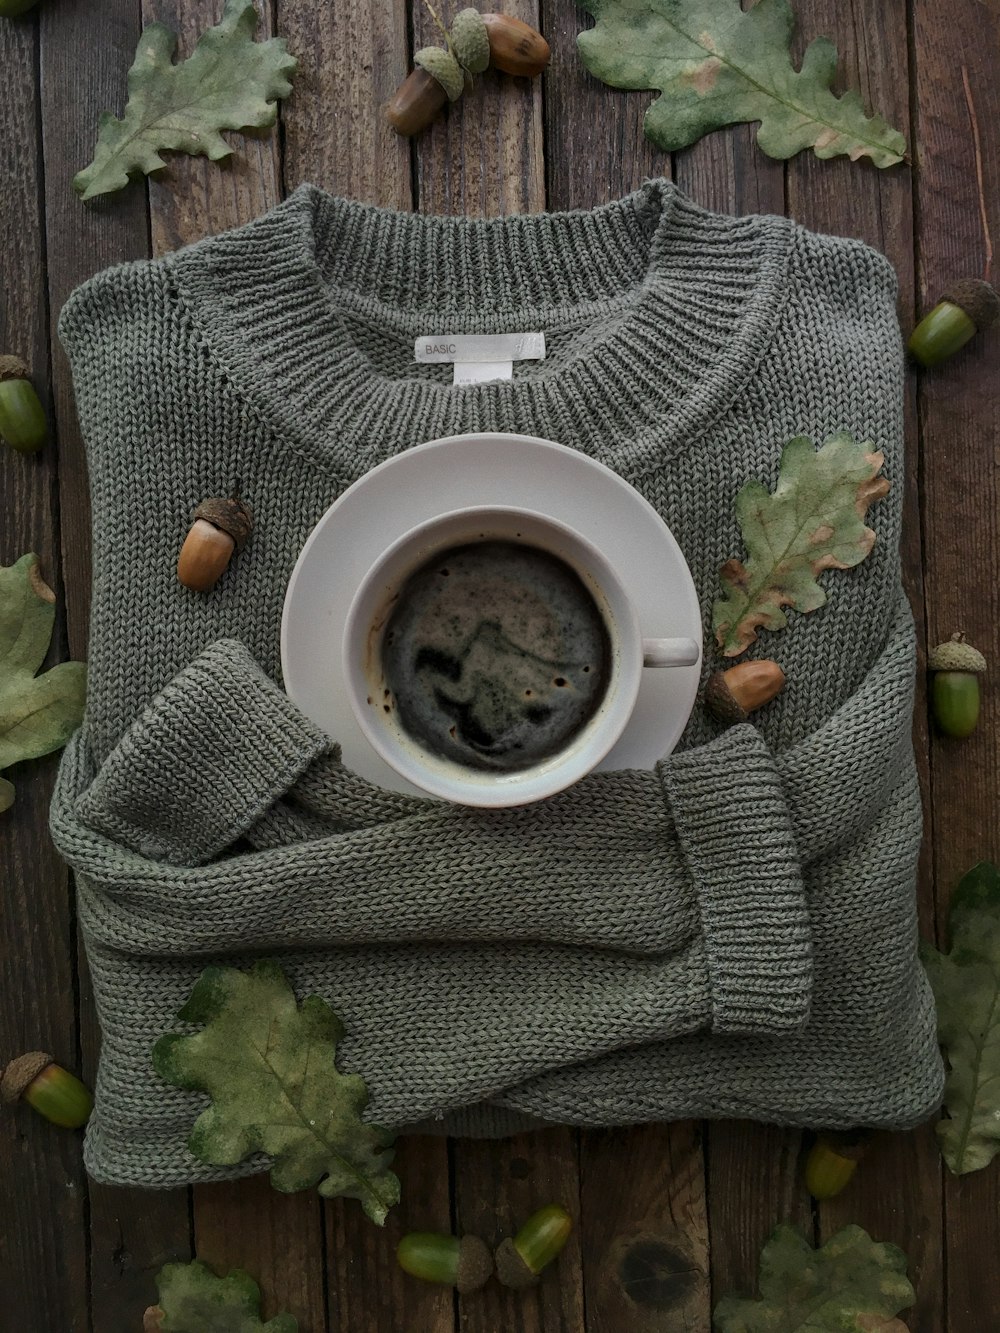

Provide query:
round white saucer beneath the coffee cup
left=281, top=435, right=701, bottom=792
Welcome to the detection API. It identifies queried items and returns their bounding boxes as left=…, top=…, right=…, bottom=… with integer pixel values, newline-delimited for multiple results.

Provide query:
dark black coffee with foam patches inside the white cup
left=376, top=541, right=611, bottom=772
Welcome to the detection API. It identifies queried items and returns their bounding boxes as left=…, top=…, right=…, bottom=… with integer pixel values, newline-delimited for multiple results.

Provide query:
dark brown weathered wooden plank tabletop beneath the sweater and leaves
left=0, top=0, right=1000, bottom=1333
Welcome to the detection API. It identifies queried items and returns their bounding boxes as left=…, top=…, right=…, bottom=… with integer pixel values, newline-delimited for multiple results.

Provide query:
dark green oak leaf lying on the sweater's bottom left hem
left=153, top=961, right=400, bottom=1225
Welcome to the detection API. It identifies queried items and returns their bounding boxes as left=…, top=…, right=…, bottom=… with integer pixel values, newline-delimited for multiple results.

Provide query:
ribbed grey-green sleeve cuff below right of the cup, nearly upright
left=657, top=725, right=812, bottom=1033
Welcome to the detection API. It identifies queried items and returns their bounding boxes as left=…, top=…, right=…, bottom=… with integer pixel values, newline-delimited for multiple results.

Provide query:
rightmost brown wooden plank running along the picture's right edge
left=917, top=0, right=1000, bottom=1333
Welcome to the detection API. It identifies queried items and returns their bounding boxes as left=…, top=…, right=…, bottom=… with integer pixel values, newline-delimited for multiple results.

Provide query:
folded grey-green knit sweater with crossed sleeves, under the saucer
left=52, top=181, right=941, bottom=1185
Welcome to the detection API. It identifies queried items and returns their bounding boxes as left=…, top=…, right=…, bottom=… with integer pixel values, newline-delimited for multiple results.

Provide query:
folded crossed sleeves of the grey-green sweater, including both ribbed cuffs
left=52, top=607, right=912, bottom=1050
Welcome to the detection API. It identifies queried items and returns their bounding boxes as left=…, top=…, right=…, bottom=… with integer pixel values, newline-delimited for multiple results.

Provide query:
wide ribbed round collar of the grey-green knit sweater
left=168, top=180, right=792, bottom=480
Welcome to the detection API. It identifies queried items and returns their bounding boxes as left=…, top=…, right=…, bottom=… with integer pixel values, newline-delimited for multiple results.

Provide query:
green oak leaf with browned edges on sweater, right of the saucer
left=712, top=431, right=889, bottom=657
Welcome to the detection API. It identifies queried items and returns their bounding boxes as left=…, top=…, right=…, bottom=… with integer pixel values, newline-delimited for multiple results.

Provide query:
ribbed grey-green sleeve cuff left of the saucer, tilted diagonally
left=76, top=640, right=335, bottom=865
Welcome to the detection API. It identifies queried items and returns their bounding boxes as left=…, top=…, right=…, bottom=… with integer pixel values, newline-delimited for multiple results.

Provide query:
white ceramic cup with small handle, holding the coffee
left=343, top=507, right=700, bottom=808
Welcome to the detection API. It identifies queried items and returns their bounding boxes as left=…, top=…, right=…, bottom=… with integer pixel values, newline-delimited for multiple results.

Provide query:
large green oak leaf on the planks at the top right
left=577, top=0, right=907, bottom=167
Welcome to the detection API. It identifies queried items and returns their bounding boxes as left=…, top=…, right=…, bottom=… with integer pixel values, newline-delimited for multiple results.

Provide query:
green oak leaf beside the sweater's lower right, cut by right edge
left=920, top=861, right=1000, bottom=1176
